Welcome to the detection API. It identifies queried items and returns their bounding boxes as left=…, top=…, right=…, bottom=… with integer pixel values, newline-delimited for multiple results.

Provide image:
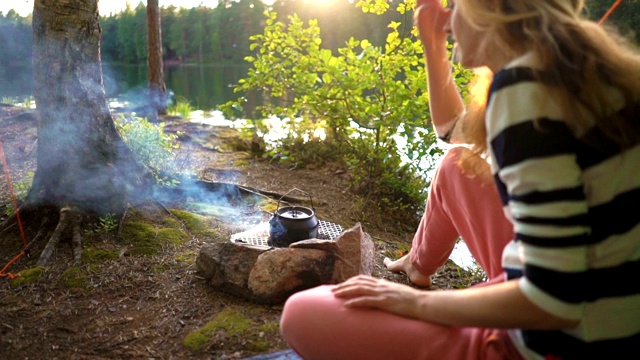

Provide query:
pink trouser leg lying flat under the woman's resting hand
left=280, top=285, right=522, bottom=360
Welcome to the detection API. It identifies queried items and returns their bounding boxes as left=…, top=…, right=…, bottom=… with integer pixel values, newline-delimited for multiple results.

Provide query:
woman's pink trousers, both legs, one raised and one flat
left=281, top=148, right=521, bottom=360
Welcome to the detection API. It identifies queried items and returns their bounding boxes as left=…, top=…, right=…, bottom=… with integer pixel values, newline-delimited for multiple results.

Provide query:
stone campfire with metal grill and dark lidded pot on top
left=196, top=189, right=375, bottom=304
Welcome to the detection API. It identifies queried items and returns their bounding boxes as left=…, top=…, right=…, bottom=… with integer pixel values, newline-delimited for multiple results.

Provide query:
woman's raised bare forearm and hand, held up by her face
left=414, top=0, right=465, bottom=142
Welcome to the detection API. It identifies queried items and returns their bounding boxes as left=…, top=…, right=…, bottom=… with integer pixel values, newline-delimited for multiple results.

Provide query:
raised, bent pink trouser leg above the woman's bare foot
left=410, top=147, right=514, bottom=279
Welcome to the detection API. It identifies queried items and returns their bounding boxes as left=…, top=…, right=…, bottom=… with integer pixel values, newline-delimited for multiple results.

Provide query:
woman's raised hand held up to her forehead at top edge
left=413, top=0, right=450, bottom=48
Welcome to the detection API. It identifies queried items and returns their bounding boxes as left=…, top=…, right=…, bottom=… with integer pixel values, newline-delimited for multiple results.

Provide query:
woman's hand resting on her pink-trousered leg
left=333, top=275, right=426, bottom=318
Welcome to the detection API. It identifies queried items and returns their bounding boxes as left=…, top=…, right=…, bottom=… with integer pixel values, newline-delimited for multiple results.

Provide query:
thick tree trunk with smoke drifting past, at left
left=27, top=0, right=153, bottom=213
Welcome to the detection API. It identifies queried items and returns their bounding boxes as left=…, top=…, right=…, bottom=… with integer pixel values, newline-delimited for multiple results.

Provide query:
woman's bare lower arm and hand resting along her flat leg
left=333, top=276, right=578, bottom=330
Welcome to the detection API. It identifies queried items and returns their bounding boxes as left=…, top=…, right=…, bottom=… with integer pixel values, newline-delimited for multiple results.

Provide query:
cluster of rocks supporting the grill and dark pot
left=196, top=224, right=375, bottom=304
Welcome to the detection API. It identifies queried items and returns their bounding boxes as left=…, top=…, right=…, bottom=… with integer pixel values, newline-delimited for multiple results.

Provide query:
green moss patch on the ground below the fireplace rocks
left=183, top=310, right=253, bottom=351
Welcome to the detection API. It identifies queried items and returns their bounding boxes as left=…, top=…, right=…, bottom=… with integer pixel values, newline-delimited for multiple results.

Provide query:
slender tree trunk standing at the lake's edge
left=147, top=0, right=167, bottom=114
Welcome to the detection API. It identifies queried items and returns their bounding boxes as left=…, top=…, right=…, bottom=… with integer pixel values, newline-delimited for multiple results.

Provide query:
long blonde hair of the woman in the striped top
left=456, top=0, right=640, bottom=165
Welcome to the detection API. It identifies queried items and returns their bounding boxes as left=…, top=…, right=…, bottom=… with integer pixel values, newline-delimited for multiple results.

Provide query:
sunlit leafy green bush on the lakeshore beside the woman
left=220, top=0, right=471, bottom=222
